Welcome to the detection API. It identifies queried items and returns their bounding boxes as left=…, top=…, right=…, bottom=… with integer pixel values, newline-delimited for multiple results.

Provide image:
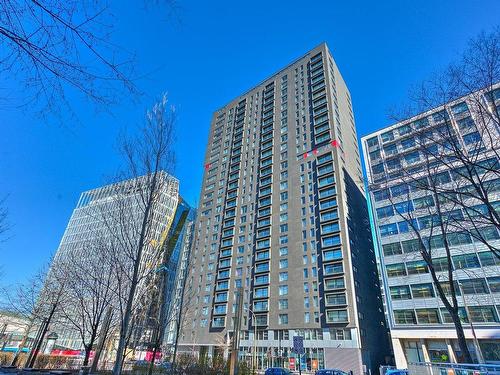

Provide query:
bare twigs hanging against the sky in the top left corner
left=0, top=0, right=138, bottom=117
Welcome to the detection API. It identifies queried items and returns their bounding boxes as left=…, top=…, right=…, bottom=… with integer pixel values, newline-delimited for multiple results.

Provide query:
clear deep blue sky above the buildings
left=0, top=0, right=500, bottom=285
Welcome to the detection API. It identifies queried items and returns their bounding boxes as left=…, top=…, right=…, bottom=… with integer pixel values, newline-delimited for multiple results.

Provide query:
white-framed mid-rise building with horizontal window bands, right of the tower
left=362, top=84, right=500, bottom=368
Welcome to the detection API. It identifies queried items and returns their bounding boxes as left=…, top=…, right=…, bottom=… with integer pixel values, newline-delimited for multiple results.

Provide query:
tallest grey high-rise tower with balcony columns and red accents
left=180, top=44, right=388, bottom=374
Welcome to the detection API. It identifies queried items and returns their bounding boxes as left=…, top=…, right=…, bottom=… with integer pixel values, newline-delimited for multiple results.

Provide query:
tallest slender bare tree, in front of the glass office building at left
left=93, top=95, right=178, bottom=374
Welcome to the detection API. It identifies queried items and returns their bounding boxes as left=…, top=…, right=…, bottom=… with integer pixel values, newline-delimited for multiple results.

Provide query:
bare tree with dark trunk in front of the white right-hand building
left=379, top=29, right=500, bottom=362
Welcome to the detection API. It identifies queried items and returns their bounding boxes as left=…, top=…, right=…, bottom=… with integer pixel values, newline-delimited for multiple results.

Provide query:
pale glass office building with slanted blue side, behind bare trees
left=49, top=172, right=195, bottom=359
